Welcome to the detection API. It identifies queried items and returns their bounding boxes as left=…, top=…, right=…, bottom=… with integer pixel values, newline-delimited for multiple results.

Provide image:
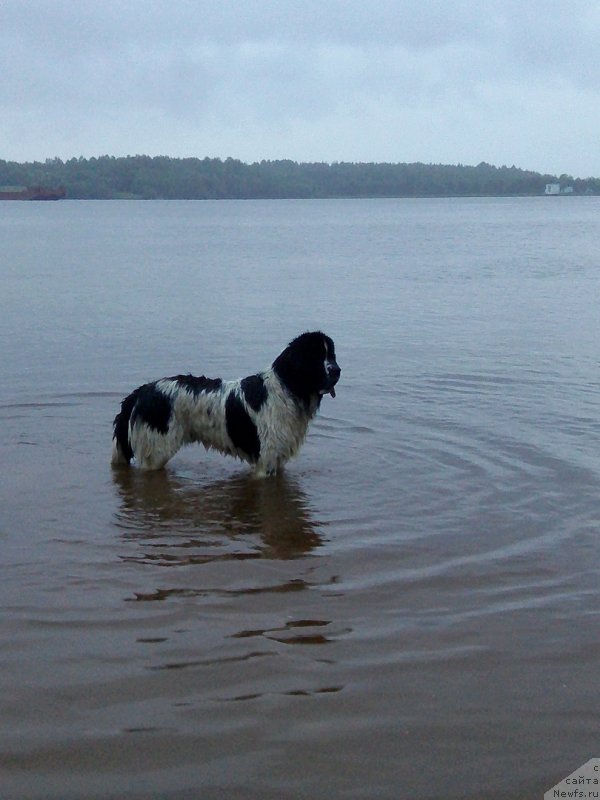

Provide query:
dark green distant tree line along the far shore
left=0, top=156, right=600, bottom=200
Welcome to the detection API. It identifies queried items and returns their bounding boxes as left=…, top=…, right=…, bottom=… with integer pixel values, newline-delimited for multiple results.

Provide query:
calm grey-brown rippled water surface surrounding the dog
left=0, top=198, right=600, bottom=800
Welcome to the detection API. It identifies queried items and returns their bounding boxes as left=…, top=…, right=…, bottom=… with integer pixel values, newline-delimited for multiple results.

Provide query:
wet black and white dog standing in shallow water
left=112, top=331, right=341, bottom=475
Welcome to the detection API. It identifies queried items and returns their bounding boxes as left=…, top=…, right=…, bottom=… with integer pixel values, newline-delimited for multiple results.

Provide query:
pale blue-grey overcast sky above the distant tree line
left=0, top=0, right=600, bottom=177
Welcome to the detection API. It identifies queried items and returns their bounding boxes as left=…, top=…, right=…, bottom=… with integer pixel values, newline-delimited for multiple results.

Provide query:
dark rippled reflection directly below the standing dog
left=113, top=469, right=322, bottom=566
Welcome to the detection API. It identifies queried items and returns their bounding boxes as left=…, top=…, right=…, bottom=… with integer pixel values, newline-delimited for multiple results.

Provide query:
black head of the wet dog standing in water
left=273, top=331, right=341, bottom=407
